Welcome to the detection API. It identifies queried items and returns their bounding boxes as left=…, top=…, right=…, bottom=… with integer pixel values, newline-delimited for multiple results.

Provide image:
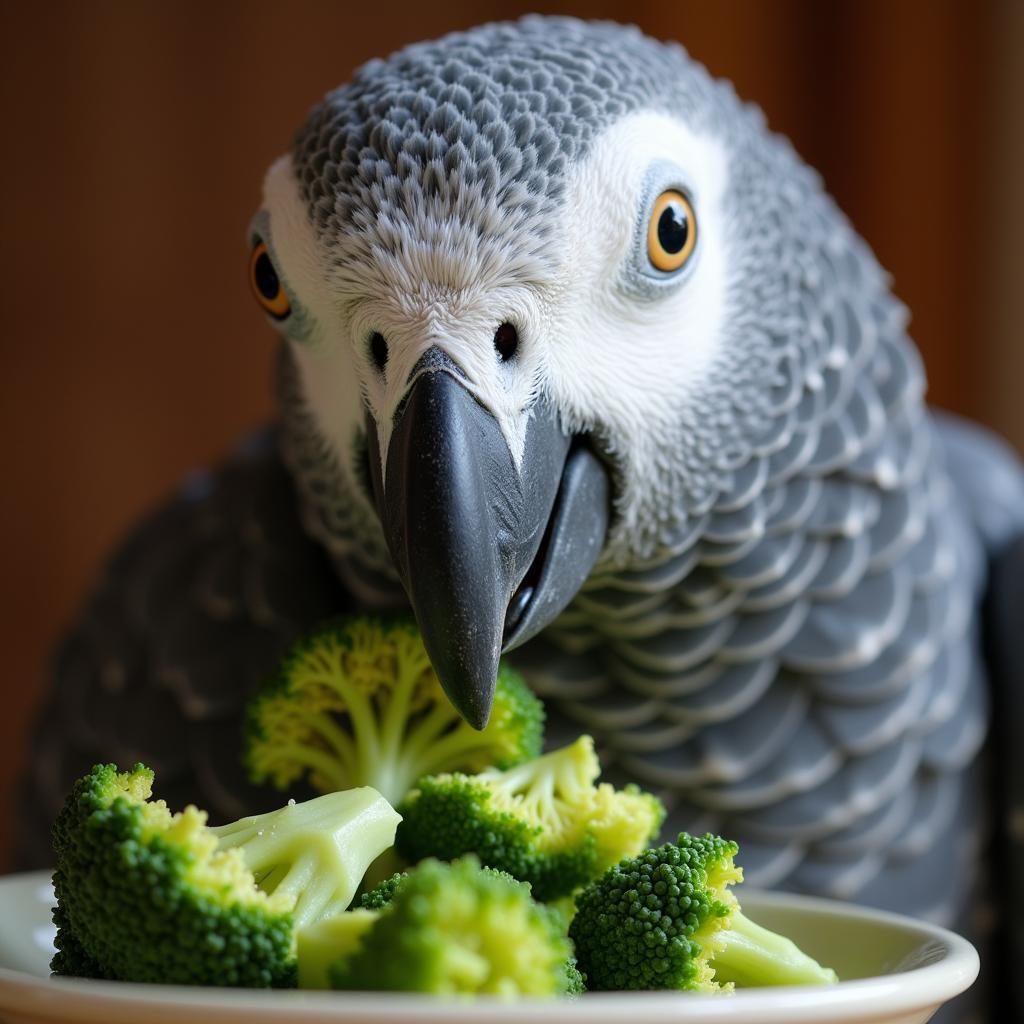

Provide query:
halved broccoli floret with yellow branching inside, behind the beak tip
left=245, top=616, right=544, bottom=803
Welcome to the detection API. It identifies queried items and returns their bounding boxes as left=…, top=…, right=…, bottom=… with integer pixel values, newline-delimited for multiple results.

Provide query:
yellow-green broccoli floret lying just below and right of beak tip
left=395, top=736, right=665, bottom=901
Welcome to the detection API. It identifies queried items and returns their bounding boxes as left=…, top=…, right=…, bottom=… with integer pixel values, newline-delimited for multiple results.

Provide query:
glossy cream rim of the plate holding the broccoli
left=0, top=870, right=980, bottom=1024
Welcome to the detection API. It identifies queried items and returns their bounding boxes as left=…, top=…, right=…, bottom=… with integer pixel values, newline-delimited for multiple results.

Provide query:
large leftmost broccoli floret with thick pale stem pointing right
left=51, top=765, right=398, bottom=987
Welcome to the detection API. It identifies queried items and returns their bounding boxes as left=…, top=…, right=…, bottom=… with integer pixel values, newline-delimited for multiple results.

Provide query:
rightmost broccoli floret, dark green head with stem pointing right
left=569, top=833, right=837, bottom=992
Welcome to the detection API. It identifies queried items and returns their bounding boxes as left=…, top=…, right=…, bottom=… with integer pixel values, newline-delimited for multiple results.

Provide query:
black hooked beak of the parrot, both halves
left=367, top=348, right=609, bottom=729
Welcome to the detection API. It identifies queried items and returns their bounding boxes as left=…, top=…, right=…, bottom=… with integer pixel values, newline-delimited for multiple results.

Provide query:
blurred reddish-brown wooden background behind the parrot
left=0, top=0, right=1024, bottom=863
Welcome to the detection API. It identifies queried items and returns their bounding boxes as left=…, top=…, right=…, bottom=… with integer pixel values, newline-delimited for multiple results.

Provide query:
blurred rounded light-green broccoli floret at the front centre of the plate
left=330, top=857, right=581, bottom=997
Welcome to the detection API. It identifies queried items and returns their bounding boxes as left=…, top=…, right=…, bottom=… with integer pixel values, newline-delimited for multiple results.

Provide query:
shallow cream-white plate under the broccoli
left=0, top=871, right=978, bottom=1024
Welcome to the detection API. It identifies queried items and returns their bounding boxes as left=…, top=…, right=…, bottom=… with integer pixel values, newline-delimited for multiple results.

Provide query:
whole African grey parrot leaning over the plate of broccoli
left=18, top=17, right=1024, bottom=1024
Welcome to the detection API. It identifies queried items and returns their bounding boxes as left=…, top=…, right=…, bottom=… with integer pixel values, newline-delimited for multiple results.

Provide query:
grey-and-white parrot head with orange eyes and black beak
left=250, top=17, right=888, bottom=727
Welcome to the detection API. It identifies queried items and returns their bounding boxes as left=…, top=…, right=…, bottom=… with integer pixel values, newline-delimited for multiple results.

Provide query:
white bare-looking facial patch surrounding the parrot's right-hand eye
left=547, top=113, right=728, bottom=439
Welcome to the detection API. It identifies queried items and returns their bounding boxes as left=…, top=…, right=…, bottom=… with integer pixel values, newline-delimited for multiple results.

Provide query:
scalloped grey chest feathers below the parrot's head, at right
left=507, top=290, right=987, bottom=921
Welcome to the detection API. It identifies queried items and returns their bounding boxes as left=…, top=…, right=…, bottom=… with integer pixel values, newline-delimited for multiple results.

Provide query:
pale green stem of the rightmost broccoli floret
left=711, top=910, right=838, bottom=988
